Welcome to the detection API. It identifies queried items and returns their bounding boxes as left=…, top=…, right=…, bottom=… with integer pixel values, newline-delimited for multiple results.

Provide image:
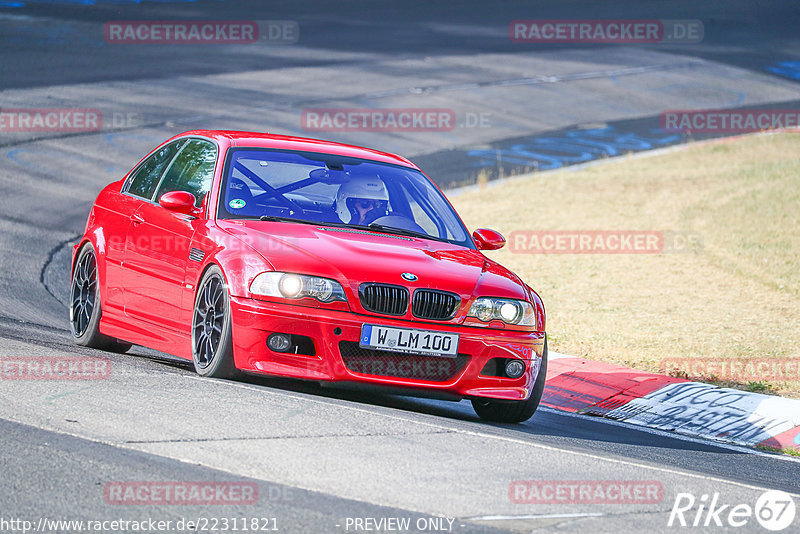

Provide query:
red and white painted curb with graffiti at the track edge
left=542, top=352, right=800, bottom=450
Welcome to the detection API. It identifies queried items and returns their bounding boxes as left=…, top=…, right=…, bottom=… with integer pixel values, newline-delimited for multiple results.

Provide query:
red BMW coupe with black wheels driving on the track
left=70, top=131, right=547, bottom=422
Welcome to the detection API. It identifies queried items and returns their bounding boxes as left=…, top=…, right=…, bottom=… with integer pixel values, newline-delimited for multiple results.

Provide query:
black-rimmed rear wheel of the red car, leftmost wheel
left=69, top=243, right=132, bottom=352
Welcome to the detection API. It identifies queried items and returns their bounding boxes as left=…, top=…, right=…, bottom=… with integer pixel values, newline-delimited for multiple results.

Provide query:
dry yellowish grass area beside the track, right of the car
left=452, top=134, right=800, bottom=397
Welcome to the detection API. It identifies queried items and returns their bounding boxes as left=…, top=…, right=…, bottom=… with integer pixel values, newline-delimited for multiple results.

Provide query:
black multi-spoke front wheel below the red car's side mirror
left=192, top=265, right=238, bottom=378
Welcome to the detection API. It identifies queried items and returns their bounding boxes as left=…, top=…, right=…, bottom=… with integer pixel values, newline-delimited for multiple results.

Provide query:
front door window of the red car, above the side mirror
left=155, top=139, right=217, bottom=206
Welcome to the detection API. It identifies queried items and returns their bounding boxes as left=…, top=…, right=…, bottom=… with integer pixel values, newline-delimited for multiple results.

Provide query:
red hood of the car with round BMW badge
left=218, top=220, right=529, bottom=302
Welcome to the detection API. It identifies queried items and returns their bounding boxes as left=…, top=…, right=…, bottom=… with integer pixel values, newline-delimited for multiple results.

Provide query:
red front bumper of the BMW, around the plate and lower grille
left=231, top=297, right=545, bottom=401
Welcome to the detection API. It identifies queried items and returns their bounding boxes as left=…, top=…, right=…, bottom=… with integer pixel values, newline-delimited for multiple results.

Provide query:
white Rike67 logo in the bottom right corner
left=667, top=490, right=796, bottom=532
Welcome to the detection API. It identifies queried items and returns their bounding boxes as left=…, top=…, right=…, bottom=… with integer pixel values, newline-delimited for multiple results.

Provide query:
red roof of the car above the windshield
left=173, top=130, right=419, bottom=169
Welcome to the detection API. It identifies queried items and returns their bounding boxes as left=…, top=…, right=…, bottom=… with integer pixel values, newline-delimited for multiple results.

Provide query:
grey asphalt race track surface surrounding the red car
left=0, top=1, right=800, bottom=532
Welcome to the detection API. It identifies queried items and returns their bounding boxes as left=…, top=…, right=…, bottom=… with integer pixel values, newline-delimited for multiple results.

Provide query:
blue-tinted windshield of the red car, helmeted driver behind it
left=217, top=148, right=474, bottom=248
